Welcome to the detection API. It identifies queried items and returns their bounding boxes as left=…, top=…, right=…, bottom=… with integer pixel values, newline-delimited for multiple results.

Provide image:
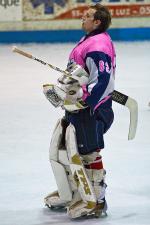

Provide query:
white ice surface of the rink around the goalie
left=0, top=42, right=150, bottom=225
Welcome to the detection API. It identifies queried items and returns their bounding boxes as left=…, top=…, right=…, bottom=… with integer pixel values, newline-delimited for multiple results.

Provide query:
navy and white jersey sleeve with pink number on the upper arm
left=82, top=51, right=114, bottom=111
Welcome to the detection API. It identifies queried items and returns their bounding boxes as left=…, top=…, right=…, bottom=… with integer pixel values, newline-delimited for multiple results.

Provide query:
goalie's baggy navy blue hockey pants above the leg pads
left=65, top=107, right=114, bottom=155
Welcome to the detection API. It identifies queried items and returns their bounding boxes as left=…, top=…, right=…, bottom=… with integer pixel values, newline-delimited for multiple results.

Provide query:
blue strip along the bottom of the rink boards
left=0, top=28, right=150, bottom=43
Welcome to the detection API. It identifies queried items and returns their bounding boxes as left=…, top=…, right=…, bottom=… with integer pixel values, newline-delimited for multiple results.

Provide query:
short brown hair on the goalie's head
left=90, top=3, right=111, bottom=32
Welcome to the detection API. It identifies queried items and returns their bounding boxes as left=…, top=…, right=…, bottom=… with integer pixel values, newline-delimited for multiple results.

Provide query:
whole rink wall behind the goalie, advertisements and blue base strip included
left=0, top=0, right=150, bottom=43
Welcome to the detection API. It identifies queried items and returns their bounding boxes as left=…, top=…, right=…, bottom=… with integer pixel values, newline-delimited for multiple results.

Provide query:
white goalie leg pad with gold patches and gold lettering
left=66, top=124, right=96, bottom=218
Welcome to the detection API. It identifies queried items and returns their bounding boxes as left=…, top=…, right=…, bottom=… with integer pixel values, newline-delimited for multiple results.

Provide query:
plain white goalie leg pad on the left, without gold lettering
left=44, top=120, right=72, bottom=207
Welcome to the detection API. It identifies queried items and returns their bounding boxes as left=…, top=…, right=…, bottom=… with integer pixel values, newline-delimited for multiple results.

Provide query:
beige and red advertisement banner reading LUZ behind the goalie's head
left=23, top=0, right=150, bottom=21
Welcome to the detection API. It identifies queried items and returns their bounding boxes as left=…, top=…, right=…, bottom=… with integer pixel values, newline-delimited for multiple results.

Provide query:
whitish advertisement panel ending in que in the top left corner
left=0, top=0, right=22, bottom=22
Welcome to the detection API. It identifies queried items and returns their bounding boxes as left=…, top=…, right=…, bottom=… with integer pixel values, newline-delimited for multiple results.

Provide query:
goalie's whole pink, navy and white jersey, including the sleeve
left=69, top=32, right=115, bottom=110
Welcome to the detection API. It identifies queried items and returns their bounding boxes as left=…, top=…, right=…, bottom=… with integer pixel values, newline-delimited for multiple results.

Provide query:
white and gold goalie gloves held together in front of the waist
left=43, top=65, right=88, bottom=111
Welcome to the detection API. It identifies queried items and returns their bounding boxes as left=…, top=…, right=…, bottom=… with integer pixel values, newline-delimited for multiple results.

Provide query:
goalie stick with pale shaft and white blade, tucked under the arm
left=12, top=46, right=138, bottom=140
